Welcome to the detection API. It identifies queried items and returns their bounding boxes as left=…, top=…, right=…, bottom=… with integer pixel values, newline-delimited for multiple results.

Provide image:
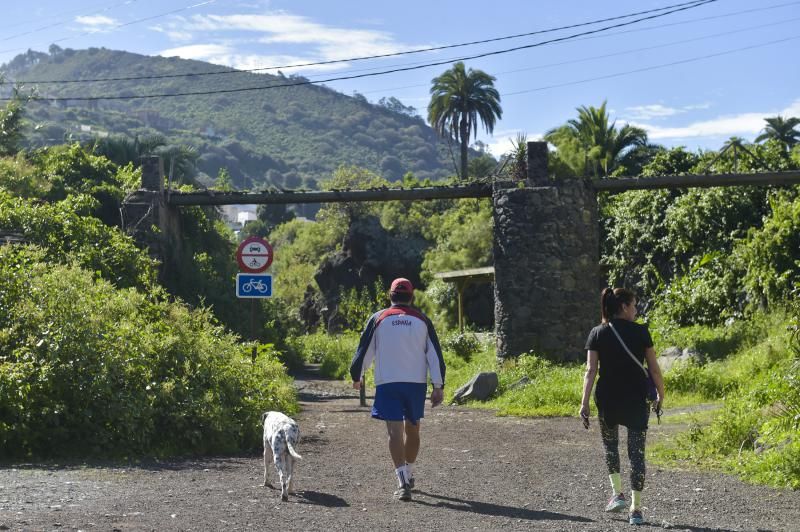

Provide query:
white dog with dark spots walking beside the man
left=261, top=412, right=302, bottom=501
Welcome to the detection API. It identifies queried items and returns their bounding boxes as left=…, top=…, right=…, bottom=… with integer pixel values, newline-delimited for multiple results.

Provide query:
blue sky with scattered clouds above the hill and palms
left=0, top=0, right=800, bottom=155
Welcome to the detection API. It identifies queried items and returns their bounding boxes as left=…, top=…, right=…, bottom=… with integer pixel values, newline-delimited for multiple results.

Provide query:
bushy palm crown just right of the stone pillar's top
left=545, top=101, right=647, bottom=177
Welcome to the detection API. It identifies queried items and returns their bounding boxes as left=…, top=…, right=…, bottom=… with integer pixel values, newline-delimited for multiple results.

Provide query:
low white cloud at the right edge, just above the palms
left=633, top=99, right=800, bottom=140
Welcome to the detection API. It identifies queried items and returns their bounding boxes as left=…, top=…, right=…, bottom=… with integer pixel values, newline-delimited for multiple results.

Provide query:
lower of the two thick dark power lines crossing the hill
left=0, top=0, right=717, bottom=101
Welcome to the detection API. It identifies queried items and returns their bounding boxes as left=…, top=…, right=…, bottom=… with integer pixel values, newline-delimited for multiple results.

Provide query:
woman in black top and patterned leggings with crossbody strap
left=580, top=288, right=664, bottom=525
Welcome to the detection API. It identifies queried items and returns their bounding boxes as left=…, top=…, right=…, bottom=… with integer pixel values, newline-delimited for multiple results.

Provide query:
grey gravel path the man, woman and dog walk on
left=0, top=370, right=800, bottom=531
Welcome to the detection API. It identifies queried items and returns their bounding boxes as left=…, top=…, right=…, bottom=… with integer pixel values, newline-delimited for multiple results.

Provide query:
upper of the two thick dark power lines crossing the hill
left=6, top=0, right=718, bottom=84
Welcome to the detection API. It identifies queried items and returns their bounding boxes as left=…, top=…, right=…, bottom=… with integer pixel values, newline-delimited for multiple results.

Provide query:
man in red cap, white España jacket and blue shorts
left=350, top=277, right=445, bottom=501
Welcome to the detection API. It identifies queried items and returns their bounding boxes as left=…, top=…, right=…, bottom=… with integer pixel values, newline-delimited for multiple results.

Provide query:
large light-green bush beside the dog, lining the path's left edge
left=0, top=251, right=297, bottom=459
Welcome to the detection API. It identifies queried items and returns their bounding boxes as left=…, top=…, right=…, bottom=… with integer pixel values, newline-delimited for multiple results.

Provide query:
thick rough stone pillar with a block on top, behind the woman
left=493, top=143, right=600, bottom=360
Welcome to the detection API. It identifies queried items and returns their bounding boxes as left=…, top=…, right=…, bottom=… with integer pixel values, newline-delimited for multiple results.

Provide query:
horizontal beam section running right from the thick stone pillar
left=591, top=171, right=800, bottom=192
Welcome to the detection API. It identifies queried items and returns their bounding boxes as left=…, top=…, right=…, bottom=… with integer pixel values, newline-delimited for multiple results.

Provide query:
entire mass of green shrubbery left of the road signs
left=0, top=139, right=296, bottom=459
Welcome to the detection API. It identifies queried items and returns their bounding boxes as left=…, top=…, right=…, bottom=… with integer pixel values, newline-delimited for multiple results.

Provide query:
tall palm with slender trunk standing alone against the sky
left=428, top=61, right=503, bottom=179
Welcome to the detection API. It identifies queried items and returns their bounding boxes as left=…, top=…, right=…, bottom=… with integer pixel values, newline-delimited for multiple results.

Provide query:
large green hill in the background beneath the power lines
left=0, top=46, right=462, bottom=188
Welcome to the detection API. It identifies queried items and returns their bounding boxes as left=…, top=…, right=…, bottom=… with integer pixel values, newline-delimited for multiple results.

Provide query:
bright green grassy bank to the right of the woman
left=648, top=314, right=800, bottom=489
